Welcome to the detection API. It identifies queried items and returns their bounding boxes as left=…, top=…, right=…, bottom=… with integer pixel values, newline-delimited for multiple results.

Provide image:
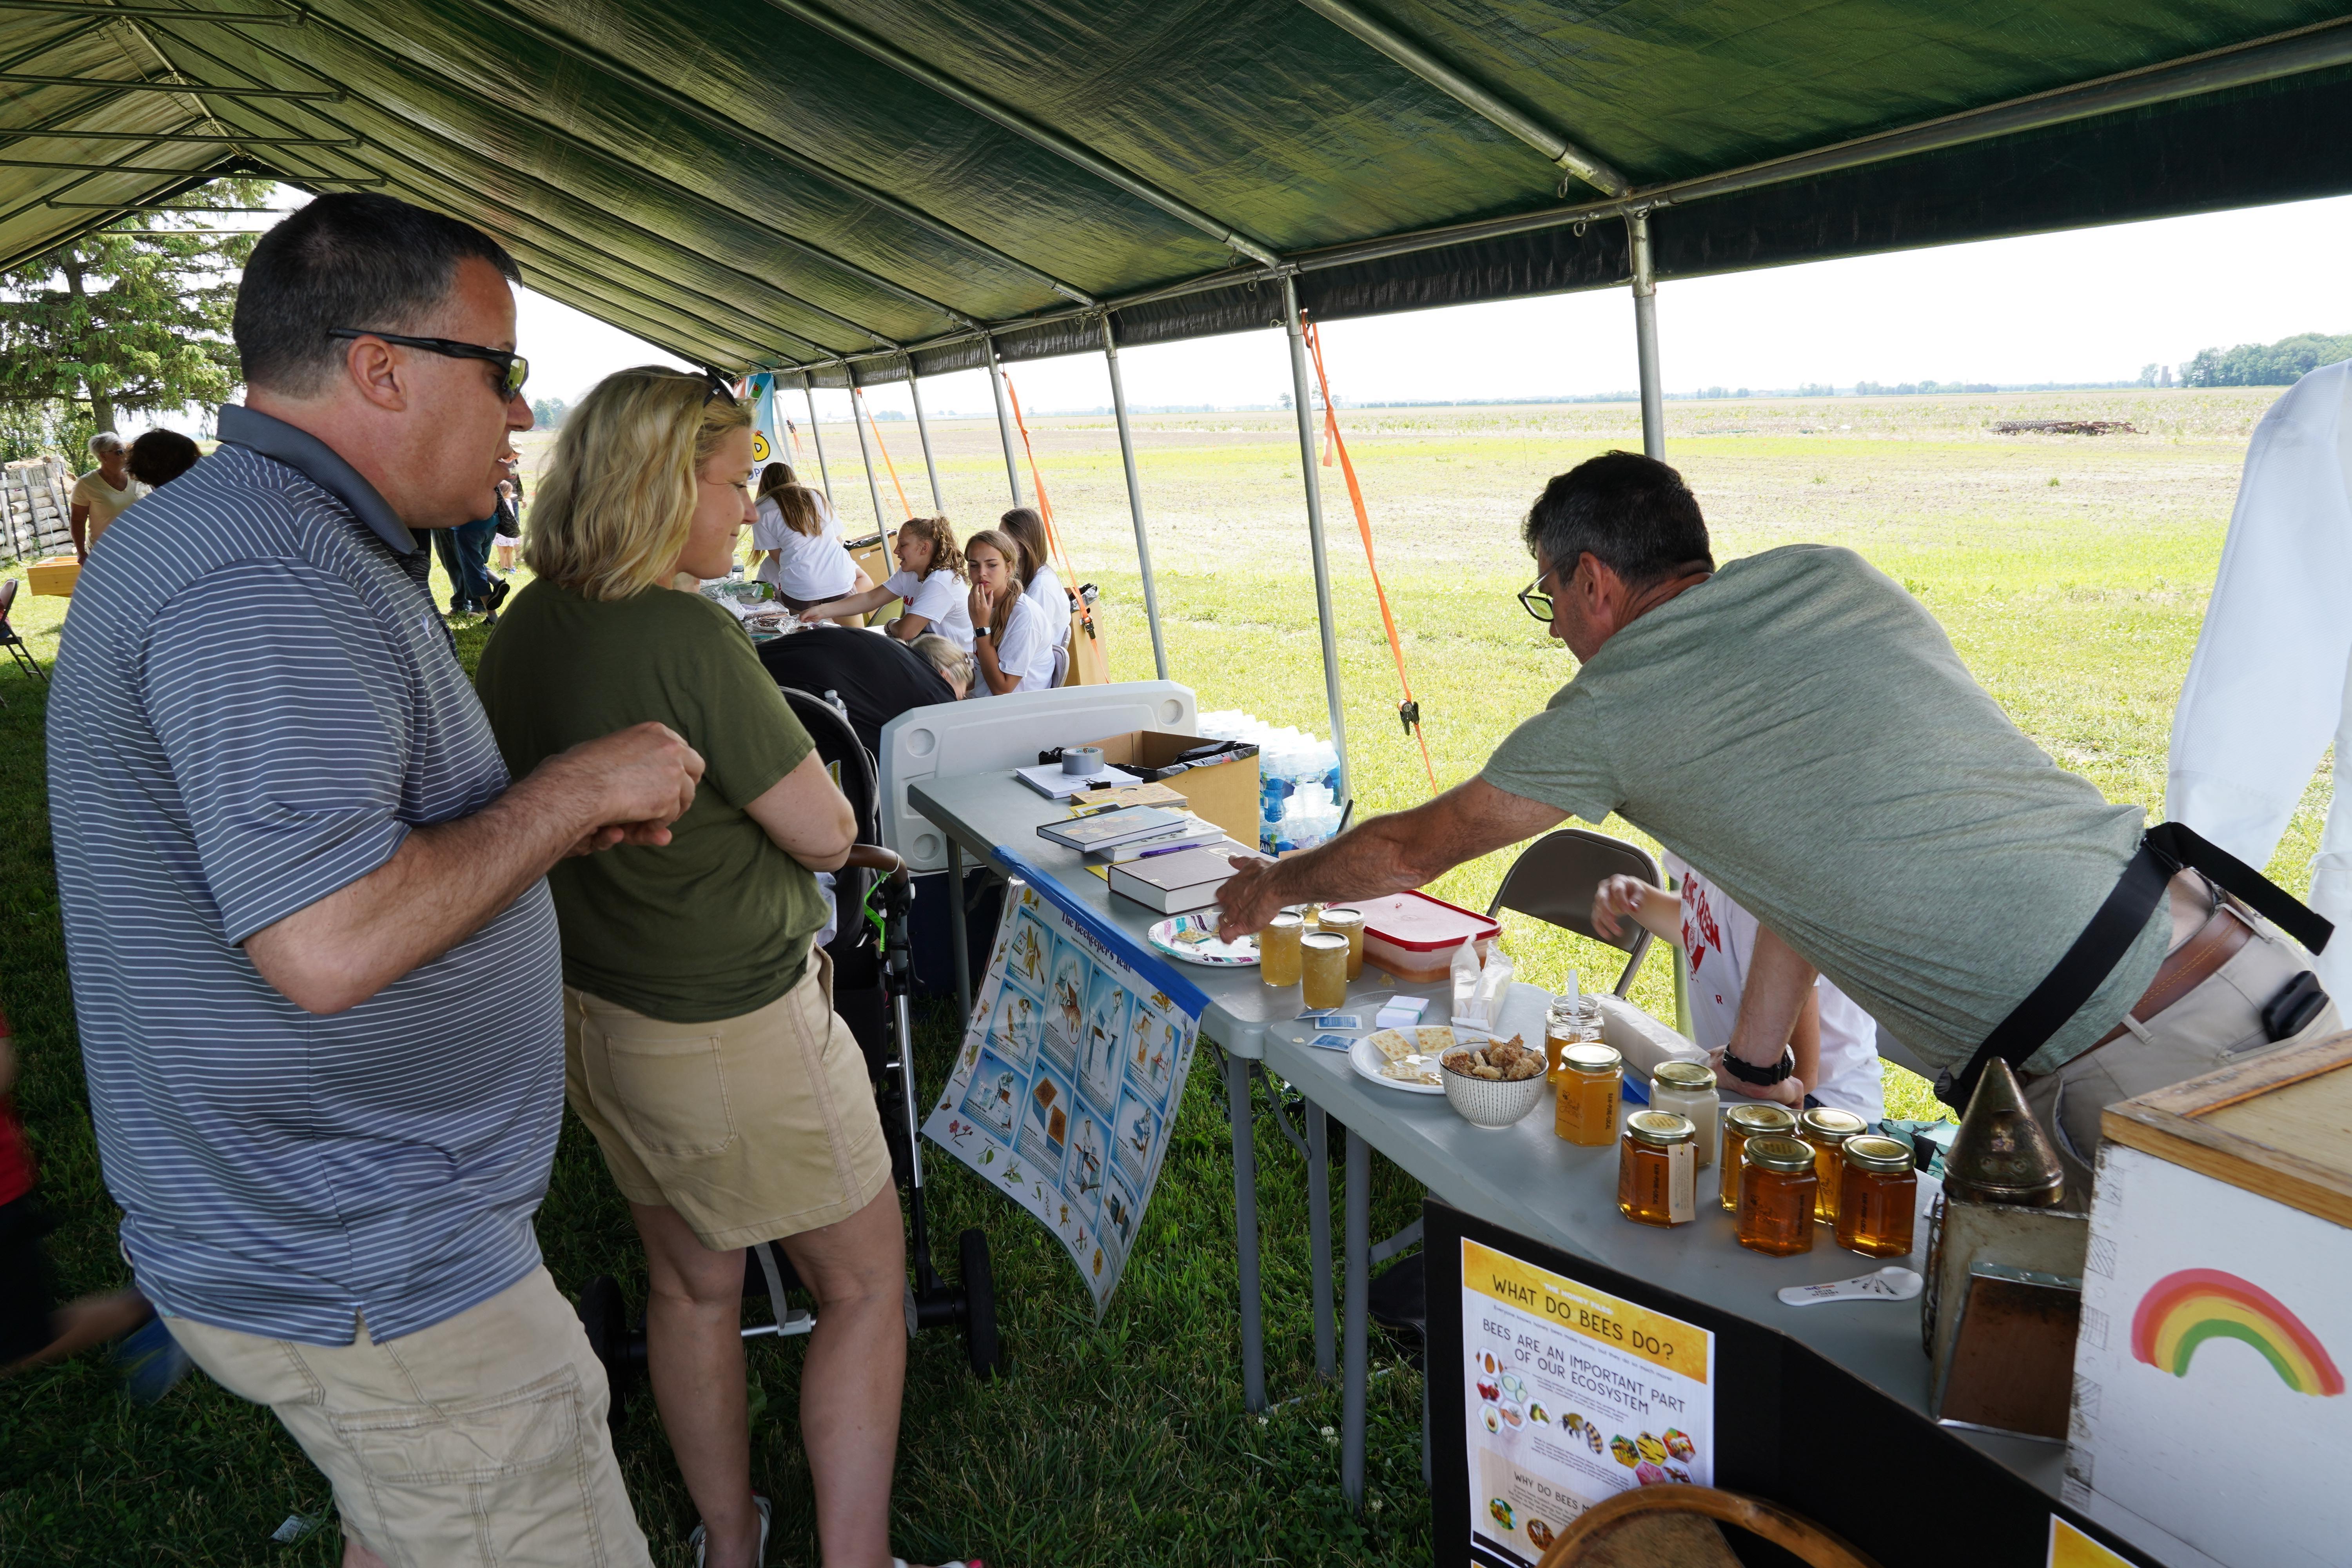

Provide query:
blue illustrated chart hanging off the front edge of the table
left=922, top=856, right=1207, bottom=1314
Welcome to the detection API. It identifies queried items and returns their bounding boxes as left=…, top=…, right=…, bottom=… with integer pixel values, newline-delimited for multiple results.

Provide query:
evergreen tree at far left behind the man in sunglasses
left=0, top=179, right=270, bottom=461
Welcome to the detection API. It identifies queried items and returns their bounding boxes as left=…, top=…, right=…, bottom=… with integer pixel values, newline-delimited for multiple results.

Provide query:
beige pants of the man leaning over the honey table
left=2025, top=907, right=2343, bottom=1208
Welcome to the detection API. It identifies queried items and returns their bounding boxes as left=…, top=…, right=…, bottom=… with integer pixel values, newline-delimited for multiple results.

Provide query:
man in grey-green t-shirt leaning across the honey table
left=1218, top=451, right=2340, bottom=1199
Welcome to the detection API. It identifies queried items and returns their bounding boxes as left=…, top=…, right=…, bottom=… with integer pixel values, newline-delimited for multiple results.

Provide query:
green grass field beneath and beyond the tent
left=0, top=385, right=2328, bottom=1568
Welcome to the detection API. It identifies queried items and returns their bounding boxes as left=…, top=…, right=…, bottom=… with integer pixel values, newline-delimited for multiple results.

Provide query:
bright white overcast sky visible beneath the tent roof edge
left=496, top=198, right=2352, bottom=416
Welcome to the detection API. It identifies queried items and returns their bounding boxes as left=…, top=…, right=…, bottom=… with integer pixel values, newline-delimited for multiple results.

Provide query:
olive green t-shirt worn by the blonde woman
left=475, top=581, right=826, bottom=1023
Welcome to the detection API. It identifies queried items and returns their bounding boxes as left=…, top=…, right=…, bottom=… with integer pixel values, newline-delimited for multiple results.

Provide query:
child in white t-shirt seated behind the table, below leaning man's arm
left=1592, top=856, right=1886, bottom=1122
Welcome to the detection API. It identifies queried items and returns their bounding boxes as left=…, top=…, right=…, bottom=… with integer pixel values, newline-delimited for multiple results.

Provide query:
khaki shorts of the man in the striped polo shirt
left=165, top=1269, right=652, bottom=1568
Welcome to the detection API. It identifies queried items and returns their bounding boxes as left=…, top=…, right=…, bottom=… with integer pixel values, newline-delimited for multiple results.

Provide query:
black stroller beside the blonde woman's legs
left=579, top=686, right=997, bottom=1425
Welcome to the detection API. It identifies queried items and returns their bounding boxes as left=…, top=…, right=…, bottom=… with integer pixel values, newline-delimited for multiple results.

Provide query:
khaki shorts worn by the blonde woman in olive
left=564, top=950, right=889, bottom=1253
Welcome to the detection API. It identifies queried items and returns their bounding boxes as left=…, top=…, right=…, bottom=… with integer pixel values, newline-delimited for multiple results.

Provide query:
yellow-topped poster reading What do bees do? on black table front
left=1463, top=1239, right=1715, bottom=1568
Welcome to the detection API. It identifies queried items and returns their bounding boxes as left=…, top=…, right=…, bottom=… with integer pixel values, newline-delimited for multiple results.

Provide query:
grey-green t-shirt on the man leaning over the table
left=1484, top=545, right=2171, bottom=1072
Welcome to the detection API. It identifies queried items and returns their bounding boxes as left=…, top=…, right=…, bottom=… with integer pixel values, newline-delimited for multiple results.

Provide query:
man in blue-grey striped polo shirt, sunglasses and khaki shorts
left=49, top=195, right=701, bottom=1568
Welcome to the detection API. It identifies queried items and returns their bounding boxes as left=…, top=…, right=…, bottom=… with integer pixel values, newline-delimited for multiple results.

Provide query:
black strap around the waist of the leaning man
left=1936, top=823, right=2336, bottom=1110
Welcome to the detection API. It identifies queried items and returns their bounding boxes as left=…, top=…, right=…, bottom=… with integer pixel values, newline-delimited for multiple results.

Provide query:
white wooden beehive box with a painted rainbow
left=2065, top=1032, right=2352, bottom=1568
